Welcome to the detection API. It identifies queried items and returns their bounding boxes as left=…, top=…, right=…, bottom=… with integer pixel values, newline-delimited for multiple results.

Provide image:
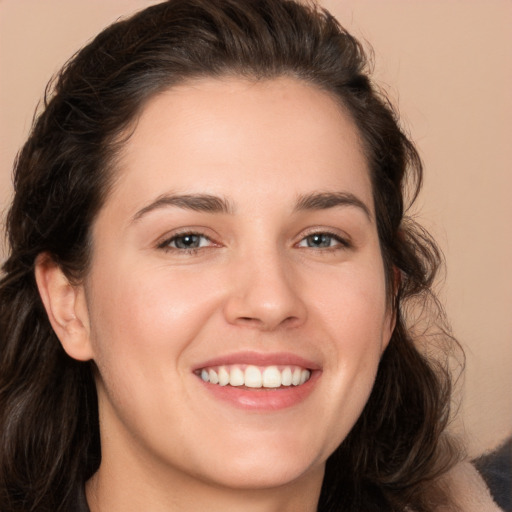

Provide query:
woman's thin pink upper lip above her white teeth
left=193, top=351, right=321, bottom=371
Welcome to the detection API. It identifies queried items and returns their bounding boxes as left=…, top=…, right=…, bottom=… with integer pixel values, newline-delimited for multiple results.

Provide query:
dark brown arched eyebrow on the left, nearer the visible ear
left=132, top=194, right=233, bottom=222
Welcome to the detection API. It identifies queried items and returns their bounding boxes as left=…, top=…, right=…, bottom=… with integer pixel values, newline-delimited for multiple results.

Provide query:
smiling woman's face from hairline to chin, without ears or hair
left=80, top=78, right=393, bottom=488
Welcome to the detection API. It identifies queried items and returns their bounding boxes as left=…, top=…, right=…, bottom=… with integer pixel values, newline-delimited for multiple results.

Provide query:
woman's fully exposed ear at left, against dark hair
left=35, top=253, right=93, bottom=361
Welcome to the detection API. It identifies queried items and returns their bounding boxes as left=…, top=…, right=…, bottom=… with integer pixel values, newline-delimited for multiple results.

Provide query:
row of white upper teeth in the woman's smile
left=201, top=365, right=311, bottom=388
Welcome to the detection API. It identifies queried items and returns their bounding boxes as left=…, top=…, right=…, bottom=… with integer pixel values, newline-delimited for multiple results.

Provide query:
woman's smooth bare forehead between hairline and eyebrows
left=107, top=78, right=372, bottom=214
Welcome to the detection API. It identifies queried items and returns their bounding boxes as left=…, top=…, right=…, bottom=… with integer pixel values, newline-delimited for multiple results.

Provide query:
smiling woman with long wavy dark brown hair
left=0, top=0, right=502, bottom=512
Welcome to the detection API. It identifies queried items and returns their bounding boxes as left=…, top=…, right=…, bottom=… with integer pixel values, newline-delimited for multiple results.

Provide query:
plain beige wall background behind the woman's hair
left=0, top=0, right=512, bottom=455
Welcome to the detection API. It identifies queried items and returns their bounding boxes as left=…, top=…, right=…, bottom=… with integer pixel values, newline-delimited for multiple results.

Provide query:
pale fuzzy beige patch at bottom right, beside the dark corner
left=438, top=462, right=502, bottom=512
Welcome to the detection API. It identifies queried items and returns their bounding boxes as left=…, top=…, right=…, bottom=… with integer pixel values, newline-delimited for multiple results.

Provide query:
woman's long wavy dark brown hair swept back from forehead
left=0, top=0, right=457, bottom=512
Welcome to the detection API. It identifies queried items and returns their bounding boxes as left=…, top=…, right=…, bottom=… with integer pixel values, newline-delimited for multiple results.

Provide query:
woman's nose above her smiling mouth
left=224, top=251, right=307, bottom=331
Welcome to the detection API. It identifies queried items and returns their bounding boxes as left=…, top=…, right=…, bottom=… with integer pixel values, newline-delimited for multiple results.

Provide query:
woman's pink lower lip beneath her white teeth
left=197, top=371, right=321, bottom=411
